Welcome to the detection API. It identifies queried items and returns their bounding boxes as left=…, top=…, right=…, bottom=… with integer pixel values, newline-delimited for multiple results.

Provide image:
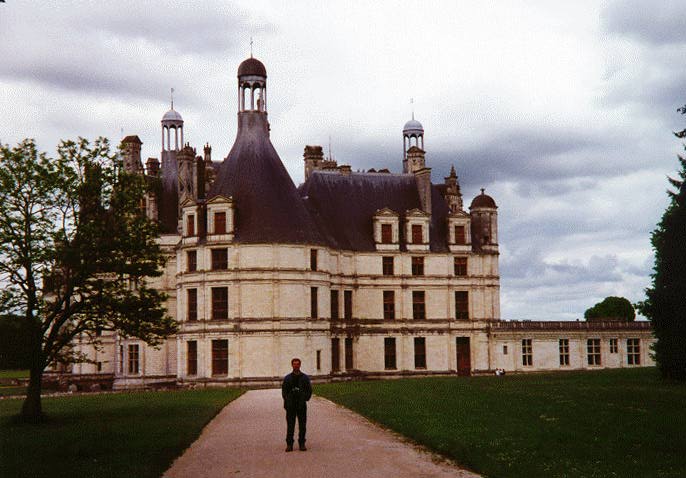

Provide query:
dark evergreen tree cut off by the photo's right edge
left=638, top=106, right=686, bottom=380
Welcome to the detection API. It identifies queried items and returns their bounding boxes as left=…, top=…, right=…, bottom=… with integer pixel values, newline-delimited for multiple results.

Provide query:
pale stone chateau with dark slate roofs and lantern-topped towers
left=72, top=57, right=653, bottom=388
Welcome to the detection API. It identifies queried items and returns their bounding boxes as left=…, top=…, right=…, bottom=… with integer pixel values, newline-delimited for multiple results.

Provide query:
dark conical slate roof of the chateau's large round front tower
left=207, top=111, right=323, bottom=244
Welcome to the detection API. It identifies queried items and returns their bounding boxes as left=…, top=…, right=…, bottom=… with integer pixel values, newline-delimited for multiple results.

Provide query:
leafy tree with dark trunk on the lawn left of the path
left=0, top=138, right=176, bottom=421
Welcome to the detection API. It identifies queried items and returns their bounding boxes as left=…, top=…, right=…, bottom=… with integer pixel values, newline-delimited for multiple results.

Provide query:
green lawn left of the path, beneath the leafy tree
left=0, top=389, right=242, bottom=478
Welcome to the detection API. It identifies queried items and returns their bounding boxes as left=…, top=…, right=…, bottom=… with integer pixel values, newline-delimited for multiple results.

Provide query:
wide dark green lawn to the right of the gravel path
left=315, top=368, right=686, bottom=478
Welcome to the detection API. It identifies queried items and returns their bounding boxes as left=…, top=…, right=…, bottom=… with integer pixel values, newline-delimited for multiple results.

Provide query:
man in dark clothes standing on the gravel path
left=281, top=358, right=312, bottom=451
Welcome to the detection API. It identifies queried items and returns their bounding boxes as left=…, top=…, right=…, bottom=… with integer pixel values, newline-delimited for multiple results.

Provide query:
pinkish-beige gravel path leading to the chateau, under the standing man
left=164, top=389, right=479, bottom=478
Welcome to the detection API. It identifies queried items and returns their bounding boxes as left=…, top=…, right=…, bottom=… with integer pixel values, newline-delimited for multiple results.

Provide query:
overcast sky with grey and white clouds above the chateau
left=0, top=0, right=686, bottom=320
